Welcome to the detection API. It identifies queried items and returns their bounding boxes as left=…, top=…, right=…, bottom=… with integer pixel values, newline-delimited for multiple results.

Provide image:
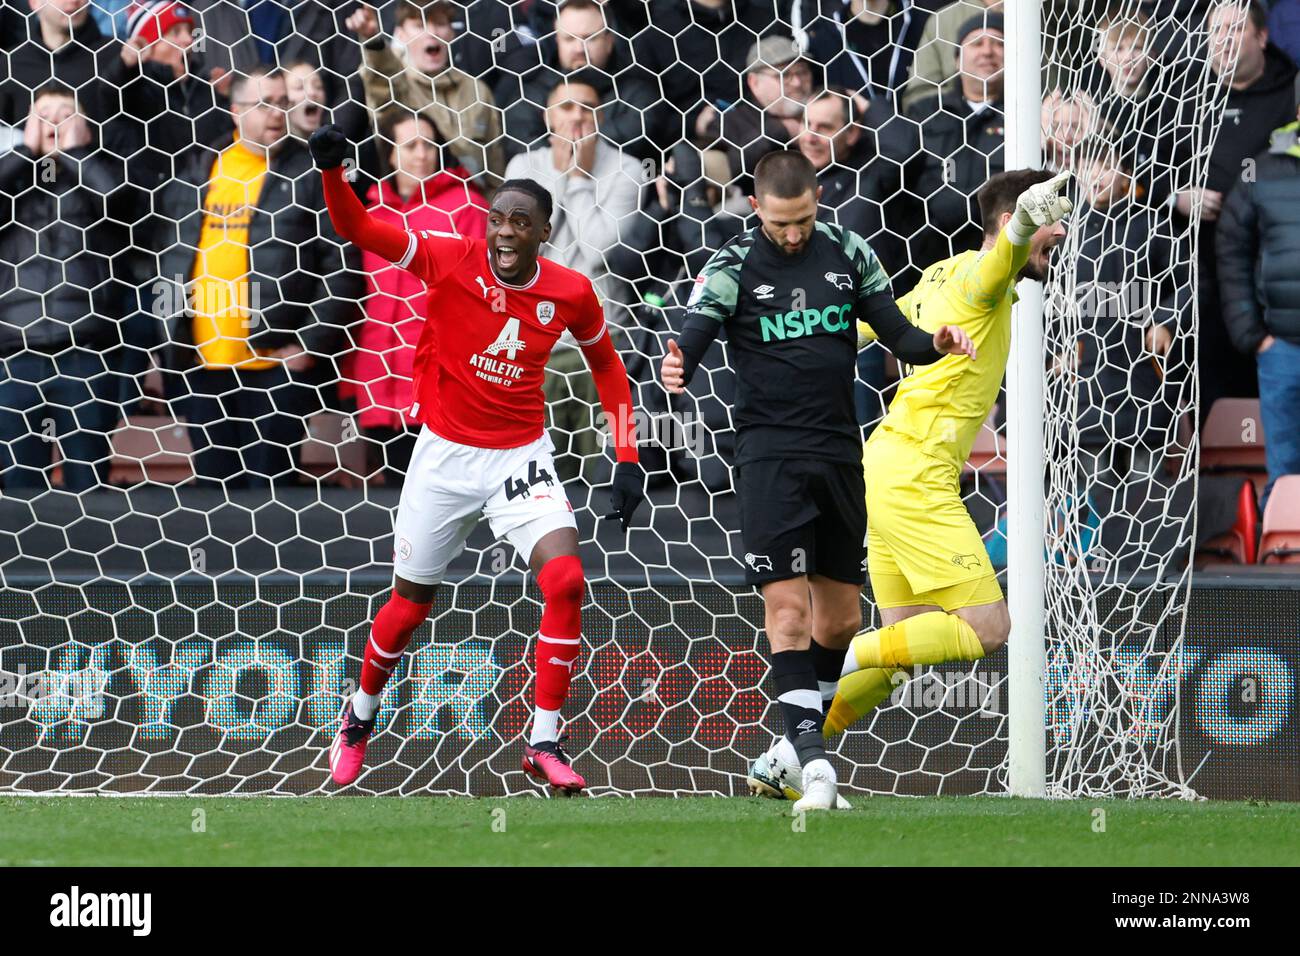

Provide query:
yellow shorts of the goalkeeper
left=862, top=432, right=1002, bottom=611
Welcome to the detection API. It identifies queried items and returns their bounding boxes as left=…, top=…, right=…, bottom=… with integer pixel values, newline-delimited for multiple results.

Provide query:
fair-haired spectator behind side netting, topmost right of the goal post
left=1084, top=10, right=1190, bottom=208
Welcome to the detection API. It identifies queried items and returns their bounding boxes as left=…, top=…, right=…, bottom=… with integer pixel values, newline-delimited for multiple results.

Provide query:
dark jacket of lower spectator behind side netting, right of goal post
left=1057, top=200, right=1192, bottom=449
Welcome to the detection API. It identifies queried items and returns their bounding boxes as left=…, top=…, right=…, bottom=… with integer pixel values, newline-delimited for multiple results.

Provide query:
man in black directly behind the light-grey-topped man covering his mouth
left=497, top=0, right=666, bottom=157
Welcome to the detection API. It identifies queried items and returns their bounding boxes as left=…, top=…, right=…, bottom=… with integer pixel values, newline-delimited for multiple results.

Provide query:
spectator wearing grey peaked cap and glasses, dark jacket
left=702, top=35, right=816, bottom=193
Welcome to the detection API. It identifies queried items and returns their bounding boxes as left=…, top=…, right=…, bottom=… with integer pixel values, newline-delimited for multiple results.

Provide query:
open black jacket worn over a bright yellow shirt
left=142, top=140, right=364, bottom=371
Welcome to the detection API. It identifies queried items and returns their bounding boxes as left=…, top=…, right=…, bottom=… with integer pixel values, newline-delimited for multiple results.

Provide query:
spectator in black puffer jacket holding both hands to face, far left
left=0, top=85, right=129, bottom=492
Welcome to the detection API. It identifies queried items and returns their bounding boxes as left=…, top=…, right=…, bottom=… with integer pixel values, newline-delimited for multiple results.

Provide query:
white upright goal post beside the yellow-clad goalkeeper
left=1004, top=0, right=1047, bottom=797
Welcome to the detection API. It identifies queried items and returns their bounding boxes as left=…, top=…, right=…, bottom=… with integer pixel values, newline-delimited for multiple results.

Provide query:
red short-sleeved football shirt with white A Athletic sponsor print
left=397, top=230, right=607, bottom=449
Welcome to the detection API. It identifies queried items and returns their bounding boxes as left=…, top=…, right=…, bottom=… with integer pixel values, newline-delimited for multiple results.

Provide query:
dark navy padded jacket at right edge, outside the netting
left=1217, top=122, right=1300, bottom=355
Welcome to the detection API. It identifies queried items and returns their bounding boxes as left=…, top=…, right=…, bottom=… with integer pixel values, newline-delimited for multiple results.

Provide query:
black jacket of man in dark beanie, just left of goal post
left=907, top=90, right=1006, bottom=268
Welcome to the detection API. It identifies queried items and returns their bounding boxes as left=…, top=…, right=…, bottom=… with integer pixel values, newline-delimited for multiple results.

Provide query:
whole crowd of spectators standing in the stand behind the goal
left=0, top=0, right=1300, bottom=504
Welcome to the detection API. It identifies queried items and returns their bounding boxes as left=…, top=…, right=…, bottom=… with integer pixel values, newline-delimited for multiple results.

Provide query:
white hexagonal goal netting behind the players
left=0, top=0, right=1242, bottom=793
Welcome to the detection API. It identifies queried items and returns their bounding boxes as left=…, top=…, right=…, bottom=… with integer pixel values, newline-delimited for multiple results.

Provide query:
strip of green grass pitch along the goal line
left=0, top=797, right=1300, bottom=866
